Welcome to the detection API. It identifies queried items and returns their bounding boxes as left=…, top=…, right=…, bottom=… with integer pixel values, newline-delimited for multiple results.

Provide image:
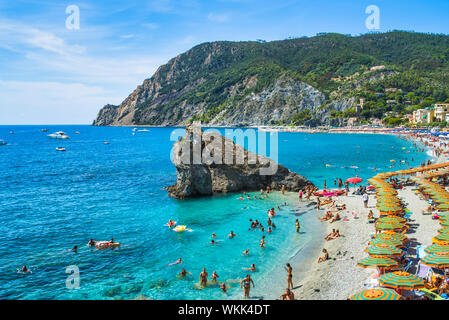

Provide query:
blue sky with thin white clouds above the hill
left=0, top=0, right=449, bottom=125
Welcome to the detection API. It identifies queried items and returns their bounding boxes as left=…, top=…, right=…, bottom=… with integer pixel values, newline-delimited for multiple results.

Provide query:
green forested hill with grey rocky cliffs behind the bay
left=94, top=31, right=449, bottom=126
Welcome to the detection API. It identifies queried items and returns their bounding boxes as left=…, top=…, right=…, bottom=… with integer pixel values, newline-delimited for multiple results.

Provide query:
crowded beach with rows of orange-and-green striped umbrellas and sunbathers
left=293, top=132, right=449, bottom=300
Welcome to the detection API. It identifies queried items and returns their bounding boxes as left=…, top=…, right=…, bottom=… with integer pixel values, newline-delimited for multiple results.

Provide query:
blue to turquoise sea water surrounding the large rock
left=0, top=126, right=428, bottom=299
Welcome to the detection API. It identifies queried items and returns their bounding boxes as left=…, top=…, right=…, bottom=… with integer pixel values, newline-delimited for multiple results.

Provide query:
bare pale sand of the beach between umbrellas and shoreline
left=293, top=132, right=447, bottom=300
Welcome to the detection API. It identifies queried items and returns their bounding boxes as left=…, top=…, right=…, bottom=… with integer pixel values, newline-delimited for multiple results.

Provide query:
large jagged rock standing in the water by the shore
left=166, top=126, right=312, bottom=199
